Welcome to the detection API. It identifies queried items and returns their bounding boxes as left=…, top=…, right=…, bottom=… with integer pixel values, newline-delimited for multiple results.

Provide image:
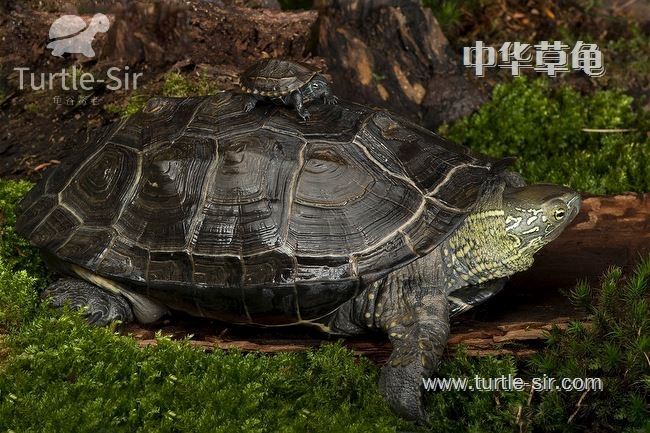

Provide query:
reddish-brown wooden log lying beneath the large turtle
left=124, top=194, right=650, bottom=364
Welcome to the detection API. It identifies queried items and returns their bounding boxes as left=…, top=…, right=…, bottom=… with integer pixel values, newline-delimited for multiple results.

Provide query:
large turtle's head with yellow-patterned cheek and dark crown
left=503, top=184, right=580, bottom=255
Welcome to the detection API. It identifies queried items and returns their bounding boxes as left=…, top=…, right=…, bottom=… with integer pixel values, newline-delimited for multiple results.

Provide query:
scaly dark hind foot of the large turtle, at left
left=41, top=278, right=134, bottom=326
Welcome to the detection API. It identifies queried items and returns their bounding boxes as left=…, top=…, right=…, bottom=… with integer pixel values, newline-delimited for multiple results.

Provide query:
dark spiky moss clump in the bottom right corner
left=531, top=257, right=650, bottom=431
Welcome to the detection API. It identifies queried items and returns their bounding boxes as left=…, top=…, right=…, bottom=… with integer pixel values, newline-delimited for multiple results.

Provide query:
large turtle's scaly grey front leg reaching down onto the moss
left=327, top=276, right=449, bottom=424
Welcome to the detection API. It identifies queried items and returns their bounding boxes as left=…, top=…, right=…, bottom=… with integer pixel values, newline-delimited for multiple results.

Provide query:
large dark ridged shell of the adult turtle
left=17, top=92, right=497, bottom=324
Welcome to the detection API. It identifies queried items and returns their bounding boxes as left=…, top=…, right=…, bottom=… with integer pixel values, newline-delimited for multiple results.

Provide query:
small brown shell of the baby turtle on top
left=240, top=59, right=318, bottom=97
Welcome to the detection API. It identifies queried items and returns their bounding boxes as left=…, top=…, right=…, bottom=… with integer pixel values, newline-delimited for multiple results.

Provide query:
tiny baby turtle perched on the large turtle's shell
left=240, top=59, right=337, bottom=120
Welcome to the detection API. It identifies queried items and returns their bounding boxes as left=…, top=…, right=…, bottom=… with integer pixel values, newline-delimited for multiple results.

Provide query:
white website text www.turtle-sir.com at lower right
left=422, top=375, right=603, bottom=391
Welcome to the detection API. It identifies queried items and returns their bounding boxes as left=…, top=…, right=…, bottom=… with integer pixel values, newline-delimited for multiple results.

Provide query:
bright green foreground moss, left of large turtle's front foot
left=0, top=313, right=407, bottom=433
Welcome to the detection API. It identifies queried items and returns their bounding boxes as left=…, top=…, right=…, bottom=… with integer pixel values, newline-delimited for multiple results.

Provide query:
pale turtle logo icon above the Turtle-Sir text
left=47, top=14, right=110, bottom=57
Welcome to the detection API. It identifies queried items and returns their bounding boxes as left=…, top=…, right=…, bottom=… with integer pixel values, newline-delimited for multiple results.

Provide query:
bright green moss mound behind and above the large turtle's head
left=440, top=78, right=650, bottom=194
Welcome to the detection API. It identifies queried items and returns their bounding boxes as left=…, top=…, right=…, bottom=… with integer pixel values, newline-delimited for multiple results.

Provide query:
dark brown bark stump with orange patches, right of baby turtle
left=314, top=0, right=484, bottom=129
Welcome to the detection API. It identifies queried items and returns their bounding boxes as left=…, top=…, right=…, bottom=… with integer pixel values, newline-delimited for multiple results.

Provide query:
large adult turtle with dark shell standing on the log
left=17, top=92, right=580, bottom=421
